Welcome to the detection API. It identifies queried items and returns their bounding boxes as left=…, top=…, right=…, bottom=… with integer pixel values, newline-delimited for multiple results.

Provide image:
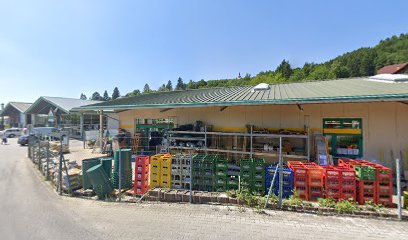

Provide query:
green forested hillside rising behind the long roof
left=122, top=34, right=408, bottom=96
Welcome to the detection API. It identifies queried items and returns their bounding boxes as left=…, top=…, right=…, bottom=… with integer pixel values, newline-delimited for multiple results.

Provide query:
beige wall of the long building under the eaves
left=119, top=102, right=408, bottom=167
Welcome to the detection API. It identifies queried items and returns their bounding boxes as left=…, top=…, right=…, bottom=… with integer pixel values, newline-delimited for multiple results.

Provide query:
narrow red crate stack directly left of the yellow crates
left=134, top=155, right=149, bottom=195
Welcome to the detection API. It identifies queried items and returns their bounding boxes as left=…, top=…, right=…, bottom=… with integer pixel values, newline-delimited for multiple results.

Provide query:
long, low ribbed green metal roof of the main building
left=75, top=78, right=408, bottom=110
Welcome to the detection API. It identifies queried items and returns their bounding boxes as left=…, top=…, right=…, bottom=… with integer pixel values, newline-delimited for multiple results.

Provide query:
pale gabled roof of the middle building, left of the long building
left=25, top=97, right=100, bottom=114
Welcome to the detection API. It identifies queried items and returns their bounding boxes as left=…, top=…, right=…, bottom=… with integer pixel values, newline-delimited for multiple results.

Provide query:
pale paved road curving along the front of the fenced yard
left=0, top=140, right=408, bottom=240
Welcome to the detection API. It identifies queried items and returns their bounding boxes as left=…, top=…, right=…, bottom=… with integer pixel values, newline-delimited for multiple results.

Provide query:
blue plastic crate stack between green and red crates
left=265, top=165, right=294, bottom=198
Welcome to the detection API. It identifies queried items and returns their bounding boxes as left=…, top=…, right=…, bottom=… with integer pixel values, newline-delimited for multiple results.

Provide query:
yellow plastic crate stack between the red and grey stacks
left=150, top=154, right=171, bottom=188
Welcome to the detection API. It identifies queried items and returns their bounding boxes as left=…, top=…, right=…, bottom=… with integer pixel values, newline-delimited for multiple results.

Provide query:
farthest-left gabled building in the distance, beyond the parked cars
left=1, top=102, right=31, bottom=127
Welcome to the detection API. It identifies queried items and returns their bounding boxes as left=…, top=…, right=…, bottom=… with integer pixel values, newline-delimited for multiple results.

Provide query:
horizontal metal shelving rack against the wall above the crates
left=166, top=126, right=310, bottom=161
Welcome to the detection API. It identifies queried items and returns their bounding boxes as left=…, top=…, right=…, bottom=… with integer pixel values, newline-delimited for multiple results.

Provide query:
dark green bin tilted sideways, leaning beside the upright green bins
left=86, top=164, right=113, bottom=196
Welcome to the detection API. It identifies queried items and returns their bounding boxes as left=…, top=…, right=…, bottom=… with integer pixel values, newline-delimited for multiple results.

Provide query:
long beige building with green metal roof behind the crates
left=76, top=74, right=408, bottom=169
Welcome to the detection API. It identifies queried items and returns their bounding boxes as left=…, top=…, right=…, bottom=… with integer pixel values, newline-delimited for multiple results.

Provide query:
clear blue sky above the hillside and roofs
left=0, top=0, right=408, bottom=103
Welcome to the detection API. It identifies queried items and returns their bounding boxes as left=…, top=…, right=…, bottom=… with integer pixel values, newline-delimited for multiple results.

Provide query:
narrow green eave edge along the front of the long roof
left=77, top=94, right=408, bottom=112
